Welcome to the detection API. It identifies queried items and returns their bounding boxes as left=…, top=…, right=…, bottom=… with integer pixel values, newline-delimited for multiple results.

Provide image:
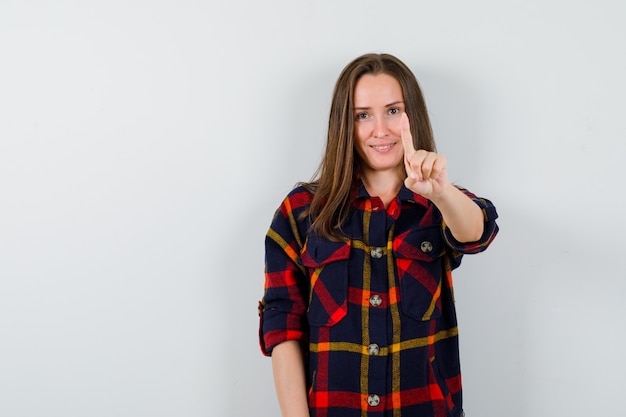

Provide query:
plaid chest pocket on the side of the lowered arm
left=301, top=235, right=350, bottom=327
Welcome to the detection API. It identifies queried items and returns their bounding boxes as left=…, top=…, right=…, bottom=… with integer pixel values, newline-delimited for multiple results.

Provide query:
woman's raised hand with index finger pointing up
left=400, top=113, right=450, bottom=200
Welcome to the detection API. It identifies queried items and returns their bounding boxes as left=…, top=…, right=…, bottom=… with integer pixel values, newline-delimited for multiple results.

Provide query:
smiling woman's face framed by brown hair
left=354, top=74, right=404, bottom=174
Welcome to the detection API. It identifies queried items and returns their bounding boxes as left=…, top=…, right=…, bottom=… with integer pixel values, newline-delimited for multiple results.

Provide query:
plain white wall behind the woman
left=0, top=0, right=626, bottom=417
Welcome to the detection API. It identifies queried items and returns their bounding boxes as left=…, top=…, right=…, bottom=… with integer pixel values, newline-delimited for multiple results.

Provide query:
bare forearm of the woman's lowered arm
left=272, top=340, right=309, bottom=417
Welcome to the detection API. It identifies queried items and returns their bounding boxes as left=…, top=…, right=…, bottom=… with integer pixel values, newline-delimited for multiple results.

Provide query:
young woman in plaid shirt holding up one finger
left=259, top=54, right=498, bottom=417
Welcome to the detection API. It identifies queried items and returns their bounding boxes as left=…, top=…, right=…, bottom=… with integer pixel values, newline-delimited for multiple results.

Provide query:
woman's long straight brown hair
left=302, top=54, right=435, bottom=240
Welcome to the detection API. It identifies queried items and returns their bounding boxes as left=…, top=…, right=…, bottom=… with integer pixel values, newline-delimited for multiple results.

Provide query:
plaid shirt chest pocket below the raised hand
left=393, top=225, right=445, bottom=321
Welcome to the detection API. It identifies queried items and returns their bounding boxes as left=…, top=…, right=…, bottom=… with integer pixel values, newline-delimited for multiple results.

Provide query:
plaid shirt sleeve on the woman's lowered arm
left=259, top=198, right=309, bottom=356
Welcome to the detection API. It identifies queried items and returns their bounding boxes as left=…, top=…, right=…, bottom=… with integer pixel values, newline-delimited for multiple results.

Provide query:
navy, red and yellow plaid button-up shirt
left=259, top=183, right=498, bottom=417
